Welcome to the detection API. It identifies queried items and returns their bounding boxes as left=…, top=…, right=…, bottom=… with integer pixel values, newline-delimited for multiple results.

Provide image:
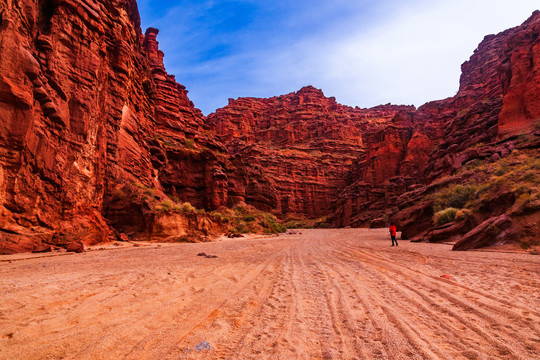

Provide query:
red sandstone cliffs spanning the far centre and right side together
left=208, top=12, right=540, bottom=250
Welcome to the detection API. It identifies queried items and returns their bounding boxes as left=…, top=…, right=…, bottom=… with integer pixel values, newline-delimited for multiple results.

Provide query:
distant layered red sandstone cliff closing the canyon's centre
left=208, top=86, right=414, bottom=217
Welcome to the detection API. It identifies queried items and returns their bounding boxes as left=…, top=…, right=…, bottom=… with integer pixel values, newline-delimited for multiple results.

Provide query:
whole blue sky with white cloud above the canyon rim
left=138, top=0, right=539, bottom=114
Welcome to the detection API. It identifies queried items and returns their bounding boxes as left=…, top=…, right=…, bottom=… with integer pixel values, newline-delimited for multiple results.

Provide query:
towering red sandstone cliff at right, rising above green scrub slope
left=388, top=11, right=540, bottom=249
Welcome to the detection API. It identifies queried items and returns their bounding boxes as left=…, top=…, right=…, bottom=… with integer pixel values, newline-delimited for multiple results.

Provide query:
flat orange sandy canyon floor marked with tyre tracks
left=0, top=229, right=540, bottom=360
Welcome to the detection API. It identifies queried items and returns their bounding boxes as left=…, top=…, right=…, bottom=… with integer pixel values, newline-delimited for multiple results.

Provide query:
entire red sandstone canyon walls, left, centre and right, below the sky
left=0, top=0, right=540, bottom=253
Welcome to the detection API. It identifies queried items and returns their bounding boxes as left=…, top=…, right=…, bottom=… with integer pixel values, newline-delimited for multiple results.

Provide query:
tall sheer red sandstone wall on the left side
left=0, top=0, right=224, bottom=252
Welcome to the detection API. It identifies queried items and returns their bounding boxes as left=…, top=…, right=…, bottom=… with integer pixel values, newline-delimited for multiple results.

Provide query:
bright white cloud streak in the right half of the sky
left=246, top=0, right=537, bottom=107
